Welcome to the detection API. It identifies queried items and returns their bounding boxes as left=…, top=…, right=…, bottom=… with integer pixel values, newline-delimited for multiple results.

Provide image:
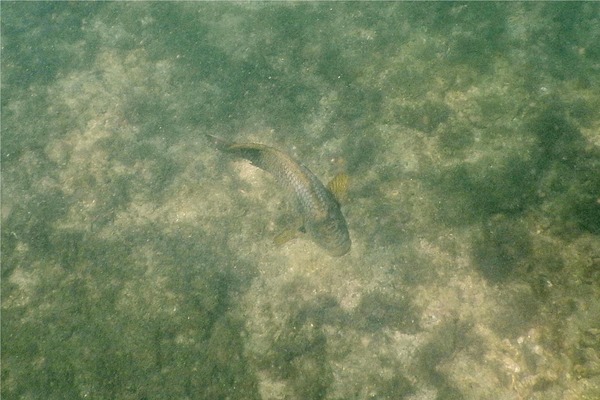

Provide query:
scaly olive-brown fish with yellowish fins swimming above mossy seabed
left=207, top=135, right=352, bottom=257
